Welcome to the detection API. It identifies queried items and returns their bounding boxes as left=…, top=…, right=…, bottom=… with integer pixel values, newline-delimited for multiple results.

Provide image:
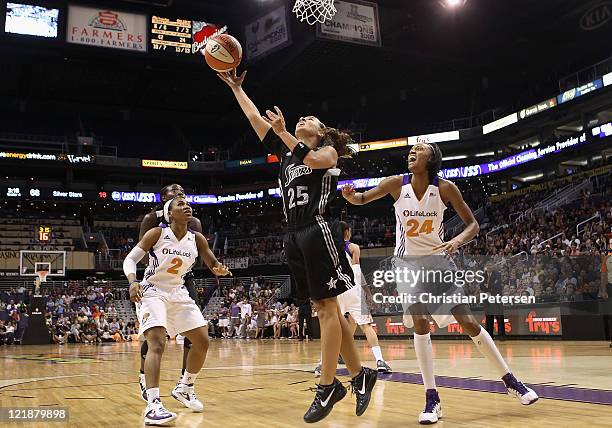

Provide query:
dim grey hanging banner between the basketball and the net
left=244, top=5, right=291, bottom=61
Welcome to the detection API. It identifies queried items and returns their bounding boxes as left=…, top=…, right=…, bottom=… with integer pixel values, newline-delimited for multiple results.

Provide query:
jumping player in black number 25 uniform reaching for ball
left=219, top=70, right=376, bottom=422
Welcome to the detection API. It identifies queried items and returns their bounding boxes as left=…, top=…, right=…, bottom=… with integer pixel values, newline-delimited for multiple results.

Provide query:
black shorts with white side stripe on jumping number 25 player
left=284, top=216, right=355, bottom=303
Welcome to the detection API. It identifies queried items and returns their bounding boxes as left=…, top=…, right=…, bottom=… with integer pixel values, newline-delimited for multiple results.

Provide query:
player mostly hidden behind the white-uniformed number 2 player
left=138, top=184, right=202, bottom=401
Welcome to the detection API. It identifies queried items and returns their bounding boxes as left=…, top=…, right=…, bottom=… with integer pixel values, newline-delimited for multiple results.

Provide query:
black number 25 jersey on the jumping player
left=263, top=129, right=340, bottom=229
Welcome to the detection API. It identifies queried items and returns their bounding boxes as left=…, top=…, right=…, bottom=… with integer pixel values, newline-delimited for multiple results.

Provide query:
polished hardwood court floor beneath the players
left=0, top=340, right=612, bottom=428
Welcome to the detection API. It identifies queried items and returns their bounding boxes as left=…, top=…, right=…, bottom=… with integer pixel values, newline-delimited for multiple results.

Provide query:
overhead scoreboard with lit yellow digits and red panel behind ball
left=151, top=16, right=227, bottom=55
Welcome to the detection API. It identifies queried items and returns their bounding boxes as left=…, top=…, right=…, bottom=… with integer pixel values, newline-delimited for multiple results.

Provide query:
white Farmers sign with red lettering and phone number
left=66, top=5, right=147, bottom=52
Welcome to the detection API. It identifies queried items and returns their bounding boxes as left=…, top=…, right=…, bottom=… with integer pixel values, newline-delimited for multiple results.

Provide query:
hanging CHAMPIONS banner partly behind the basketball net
left=317, top=0, right=381, bottom=46
